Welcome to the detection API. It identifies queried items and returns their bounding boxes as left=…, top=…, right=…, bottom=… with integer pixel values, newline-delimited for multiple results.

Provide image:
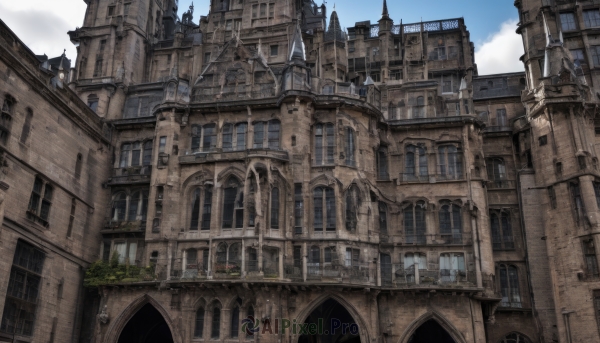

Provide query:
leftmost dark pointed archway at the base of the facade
left=118, top=304, right=173, bottom=343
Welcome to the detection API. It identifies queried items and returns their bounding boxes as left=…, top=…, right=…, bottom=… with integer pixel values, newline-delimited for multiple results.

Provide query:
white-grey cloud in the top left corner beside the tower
left=0, top=0, right=87, bottom=63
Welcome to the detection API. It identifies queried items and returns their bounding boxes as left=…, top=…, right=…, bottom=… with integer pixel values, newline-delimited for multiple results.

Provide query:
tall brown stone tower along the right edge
left=513, top=1, right=600, bottom=342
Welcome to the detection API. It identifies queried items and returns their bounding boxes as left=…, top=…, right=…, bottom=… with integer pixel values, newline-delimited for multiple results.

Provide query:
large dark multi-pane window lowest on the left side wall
left=0, top=241, right=45, bottom=336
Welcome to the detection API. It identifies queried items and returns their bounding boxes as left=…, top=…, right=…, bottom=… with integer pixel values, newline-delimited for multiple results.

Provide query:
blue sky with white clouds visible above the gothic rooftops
left=0, top=0, right=523, bottom=75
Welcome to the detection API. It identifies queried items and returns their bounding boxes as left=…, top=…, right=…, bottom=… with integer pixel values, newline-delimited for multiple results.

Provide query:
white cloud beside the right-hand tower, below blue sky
left=475, top=19, right=525, bottom=75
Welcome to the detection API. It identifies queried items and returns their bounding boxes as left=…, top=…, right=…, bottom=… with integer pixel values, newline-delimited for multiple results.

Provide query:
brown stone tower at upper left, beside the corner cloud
left=69, top=0, right=171, bottom=117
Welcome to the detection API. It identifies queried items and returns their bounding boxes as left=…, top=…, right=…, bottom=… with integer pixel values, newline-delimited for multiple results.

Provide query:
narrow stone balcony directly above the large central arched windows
left=179, top=149, right=290, bottom=164
